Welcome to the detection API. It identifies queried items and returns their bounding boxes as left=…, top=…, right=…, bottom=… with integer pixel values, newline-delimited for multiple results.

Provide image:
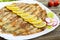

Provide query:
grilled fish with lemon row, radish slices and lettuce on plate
left=0, top=3, right=57, bottom=36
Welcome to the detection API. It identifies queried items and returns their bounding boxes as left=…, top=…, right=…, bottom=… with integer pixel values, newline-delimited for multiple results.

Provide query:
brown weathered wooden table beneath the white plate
left=0, top=0, right=60, bottom=40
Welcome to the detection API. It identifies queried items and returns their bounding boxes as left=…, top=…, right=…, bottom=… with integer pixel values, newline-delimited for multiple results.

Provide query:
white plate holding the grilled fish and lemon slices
left=0, top=1, right=59, bottom=40
